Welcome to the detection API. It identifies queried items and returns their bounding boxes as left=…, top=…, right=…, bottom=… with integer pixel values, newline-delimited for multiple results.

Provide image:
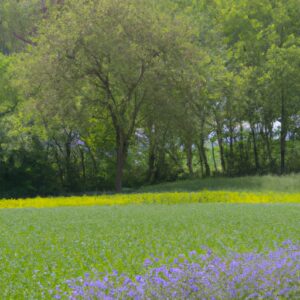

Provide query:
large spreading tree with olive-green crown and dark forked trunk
left=19, top=0, right=199, bottom=192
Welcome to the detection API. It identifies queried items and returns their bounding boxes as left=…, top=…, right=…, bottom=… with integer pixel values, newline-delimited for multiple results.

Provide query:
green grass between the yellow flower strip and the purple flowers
left=0, top=204, right=300, bottom=299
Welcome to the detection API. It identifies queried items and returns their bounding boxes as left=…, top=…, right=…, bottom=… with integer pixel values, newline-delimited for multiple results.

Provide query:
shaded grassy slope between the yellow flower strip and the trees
left=138, top=174, right=300, bottom=193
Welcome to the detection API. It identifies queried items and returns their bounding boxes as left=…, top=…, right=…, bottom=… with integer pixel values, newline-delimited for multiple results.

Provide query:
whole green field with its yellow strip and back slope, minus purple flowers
left=0, top=175, right=300, bottom=299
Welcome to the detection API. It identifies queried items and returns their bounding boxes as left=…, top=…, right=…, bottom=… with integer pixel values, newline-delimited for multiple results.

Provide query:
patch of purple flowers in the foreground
left=57, top=242, right=300, bottom=300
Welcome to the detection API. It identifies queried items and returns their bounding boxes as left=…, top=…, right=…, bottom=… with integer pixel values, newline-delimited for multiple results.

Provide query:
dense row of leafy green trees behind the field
left=0, top=0, right=300, bottom=196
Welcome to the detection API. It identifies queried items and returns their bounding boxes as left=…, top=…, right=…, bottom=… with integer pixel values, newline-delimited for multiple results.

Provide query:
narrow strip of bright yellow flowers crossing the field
left=0, top=191, right=300, bottom=209
